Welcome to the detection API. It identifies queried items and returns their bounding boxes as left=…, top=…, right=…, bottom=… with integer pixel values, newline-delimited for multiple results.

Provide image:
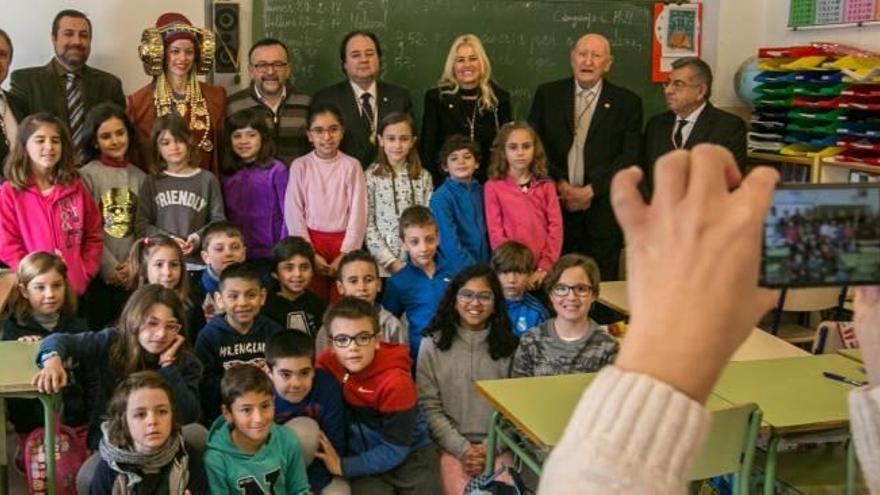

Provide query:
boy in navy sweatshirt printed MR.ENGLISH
left=195, top=263, right=283, bottom=425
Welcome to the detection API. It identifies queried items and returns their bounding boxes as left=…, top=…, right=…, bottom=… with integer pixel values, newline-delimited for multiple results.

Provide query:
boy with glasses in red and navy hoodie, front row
left=317, top=297, right=441, bottom=495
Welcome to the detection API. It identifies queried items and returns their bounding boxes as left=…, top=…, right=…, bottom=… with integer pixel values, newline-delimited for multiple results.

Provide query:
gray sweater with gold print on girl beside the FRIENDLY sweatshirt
left=79, top=160, right=146, bottom=279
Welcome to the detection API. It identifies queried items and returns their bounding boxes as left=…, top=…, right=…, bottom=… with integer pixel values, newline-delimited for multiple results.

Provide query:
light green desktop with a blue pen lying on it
left=713, top=354, right=864, bottom=433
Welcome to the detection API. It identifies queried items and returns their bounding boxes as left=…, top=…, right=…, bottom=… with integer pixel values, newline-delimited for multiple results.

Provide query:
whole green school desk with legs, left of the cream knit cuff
left=476, top=373, right=731, bottom=474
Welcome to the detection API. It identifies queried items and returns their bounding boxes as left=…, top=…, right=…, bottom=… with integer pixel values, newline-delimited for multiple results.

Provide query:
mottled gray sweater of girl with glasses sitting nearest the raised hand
left=512, top=318, right=619, bottom=377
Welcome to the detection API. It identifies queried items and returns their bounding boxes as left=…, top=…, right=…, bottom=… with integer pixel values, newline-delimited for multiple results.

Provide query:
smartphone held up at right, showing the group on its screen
left=761, top=184, right=880, bottom=287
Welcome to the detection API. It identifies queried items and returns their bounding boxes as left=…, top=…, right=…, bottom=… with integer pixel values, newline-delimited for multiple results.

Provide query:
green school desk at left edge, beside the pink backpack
left=0, top=341, right=55, bottom=495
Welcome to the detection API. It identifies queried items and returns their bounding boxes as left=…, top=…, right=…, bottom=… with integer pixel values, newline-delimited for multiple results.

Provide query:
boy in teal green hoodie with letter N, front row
left=205, top=365, right=309, bottom=495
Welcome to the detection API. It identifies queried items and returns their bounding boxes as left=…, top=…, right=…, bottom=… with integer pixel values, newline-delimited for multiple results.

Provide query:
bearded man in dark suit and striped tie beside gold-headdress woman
left=10, top=9, right=125, bottom=144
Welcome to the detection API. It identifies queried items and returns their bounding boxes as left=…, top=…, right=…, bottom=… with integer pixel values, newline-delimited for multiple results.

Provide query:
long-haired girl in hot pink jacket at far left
left=0, top=113, right=103, bottom=295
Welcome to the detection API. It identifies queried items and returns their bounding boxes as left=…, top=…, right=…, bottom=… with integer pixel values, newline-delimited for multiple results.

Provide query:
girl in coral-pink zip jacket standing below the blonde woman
left=483, top=122, right=562, bottom=289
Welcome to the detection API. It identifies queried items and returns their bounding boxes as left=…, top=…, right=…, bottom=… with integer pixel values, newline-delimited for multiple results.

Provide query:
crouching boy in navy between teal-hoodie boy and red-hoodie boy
left=266, top=332, right=348, bottom=495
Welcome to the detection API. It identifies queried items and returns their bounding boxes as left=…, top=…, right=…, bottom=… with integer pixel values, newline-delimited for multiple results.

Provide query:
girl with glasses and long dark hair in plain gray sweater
left=416, top=265, right=517, bottom=495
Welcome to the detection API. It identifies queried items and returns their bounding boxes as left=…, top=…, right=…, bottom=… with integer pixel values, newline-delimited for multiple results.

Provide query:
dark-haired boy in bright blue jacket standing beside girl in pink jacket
left=431, top=134, right=492, bottom=275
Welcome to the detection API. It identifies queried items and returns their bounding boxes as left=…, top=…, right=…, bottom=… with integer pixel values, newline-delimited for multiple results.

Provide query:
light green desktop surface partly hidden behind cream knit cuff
left=476, top=373, right=731, bottom=452
